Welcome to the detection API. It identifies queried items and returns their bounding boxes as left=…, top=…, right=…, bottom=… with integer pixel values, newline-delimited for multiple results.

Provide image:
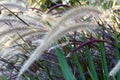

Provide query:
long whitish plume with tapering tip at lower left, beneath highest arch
left=18, top=23, right=96, bottom=77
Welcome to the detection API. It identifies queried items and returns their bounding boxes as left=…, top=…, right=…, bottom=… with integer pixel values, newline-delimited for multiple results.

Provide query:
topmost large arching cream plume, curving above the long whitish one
left=42, top=6, right=102, bottom=41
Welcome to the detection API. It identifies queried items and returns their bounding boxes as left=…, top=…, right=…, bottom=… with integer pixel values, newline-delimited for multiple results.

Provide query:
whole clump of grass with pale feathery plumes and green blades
left=0, top=0, right=120, bottom=80
